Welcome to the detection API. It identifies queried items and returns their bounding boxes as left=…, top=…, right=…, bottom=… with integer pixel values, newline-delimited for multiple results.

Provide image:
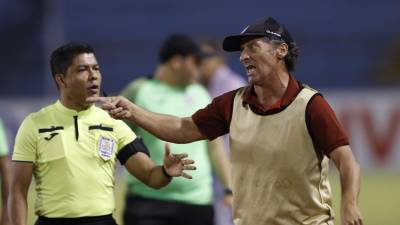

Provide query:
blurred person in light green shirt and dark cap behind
left=122, top=34, right=229, bottom=225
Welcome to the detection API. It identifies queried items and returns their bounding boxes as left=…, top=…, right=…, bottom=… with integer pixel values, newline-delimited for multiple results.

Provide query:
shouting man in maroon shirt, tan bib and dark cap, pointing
left=88, top=18, right=363, bottom=225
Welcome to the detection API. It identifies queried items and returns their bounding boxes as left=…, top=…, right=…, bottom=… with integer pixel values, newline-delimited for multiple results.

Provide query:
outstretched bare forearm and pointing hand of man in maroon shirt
left=87, top=96, right=206, bottom=143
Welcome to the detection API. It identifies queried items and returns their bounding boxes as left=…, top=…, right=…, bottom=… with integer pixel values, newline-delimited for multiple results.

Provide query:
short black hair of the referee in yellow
left=50, top=42, right=95, bottom=77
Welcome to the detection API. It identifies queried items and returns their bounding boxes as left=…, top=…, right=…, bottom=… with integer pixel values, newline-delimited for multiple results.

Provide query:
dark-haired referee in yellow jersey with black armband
left=9, top=43, right=195, bottom=225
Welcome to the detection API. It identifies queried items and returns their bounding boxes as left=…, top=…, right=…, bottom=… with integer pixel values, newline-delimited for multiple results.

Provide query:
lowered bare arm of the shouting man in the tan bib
left=330, top=145, right=363, bottom=225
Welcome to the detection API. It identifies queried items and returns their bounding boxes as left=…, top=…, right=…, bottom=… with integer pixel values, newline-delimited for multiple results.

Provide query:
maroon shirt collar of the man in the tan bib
left=243, top=75, right=301, bottom=114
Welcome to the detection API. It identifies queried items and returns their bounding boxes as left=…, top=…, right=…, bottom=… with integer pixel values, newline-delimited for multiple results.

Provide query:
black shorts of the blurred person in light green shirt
left=124, top=197, right=214, bottom=225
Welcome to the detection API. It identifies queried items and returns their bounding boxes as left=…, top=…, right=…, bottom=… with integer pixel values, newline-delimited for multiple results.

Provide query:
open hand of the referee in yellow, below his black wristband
left=163, top=143, right=196, bottom=179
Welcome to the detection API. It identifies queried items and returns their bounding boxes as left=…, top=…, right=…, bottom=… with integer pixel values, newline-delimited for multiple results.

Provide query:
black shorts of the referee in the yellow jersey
left=35, top=214, right=117, bottom=225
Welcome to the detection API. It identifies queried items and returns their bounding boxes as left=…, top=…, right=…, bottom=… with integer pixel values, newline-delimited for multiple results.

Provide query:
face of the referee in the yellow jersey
left=60, top=53, right=101, bottom=108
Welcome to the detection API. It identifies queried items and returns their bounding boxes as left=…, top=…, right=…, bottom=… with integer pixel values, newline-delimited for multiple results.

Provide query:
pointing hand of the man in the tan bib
left=86, top=96, right=134, bottom=120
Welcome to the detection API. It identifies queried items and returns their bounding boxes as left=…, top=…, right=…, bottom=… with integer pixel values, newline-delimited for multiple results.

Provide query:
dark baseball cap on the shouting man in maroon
left=222, top=17, right=294, bottom=52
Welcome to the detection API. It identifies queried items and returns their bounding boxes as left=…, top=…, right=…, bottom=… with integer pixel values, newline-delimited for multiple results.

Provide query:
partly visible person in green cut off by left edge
left=0, top=118, right=11, bottom=225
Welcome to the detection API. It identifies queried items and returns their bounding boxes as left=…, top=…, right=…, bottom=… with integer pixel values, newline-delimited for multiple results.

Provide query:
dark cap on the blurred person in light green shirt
left=159, top=34, right=203, bottom=63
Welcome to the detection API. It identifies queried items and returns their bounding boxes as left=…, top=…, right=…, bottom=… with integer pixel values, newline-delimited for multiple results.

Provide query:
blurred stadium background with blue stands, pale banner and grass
left=0, top=0, right=400, bottom=225
